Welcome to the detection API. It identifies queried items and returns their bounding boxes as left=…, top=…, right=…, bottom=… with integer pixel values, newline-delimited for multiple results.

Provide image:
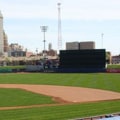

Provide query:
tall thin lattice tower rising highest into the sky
left=57, top=2, right=62, bottom=51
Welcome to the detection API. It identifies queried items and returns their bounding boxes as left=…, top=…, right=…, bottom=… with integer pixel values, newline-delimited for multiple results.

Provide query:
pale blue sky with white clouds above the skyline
left=0, top=0, right=120, bottom=55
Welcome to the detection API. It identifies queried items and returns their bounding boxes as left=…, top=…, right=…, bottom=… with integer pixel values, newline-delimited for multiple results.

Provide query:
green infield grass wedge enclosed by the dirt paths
left=0, top=88, right=55, bottom=107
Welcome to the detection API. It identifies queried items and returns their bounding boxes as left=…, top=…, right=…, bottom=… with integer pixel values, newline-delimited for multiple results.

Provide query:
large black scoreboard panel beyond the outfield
left=60, top=49, right=106, bottom=68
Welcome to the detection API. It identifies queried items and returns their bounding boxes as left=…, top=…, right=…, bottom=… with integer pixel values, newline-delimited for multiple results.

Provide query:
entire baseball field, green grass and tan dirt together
left=0, top=73, right=120, bottom=120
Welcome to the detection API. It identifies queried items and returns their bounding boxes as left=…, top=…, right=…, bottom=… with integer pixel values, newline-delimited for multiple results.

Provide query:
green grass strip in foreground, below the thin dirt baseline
left=0, top=101, right=120, bottom=120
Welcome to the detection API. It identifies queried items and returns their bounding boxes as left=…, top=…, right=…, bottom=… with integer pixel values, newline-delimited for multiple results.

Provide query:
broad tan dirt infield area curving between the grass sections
left=0, top=84, right=120, bottom=103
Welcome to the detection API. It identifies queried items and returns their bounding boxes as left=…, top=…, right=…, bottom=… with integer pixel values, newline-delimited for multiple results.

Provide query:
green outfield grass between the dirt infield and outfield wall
left=0, top=73, right=120, bottom=92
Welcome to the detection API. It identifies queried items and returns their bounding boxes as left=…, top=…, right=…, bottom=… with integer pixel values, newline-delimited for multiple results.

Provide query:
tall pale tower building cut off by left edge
left=0, top=11, right=4, bottom=56
